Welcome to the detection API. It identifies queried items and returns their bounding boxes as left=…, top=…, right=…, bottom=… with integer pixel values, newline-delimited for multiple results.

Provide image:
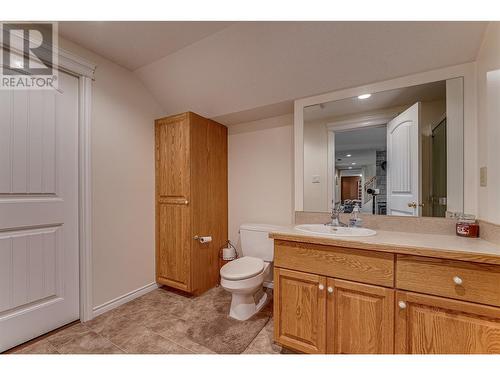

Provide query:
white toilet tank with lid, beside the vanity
left=240, top=224, right=284, bottom=262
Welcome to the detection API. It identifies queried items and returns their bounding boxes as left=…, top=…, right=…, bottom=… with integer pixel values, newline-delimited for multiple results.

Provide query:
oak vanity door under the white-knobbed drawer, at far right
left=395, top=292, right=500, bottom=354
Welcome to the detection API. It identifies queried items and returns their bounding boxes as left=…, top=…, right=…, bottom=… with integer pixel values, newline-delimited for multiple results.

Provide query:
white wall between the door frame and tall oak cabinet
left=60, top=40, right=162, bottom=307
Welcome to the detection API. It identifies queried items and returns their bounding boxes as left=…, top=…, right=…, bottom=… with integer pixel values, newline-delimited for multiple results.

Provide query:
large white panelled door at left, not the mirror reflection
left=0, top=73, right=79, bottom=352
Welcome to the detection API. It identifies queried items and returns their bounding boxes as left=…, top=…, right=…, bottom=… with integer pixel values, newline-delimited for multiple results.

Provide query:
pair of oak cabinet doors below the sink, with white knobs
left=274, top=268, right=394, bottom=354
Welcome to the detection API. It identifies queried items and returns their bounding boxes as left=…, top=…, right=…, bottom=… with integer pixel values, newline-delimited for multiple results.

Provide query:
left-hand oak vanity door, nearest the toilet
left=274, top=268, right=326, bottom=353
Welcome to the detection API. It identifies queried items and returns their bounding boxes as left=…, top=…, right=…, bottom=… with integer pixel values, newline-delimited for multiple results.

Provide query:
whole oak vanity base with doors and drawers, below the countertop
left=274, top=239, right=500, bottom=354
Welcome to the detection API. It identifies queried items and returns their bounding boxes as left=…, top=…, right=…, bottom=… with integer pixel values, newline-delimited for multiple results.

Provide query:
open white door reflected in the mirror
left=387, top=103, right=421, bottom=216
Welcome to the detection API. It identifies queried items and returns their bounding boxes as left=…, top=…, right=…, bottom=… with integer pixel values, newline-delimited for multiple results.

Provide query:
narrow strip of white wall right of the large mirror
left=476, top=22, right=500, bottom=224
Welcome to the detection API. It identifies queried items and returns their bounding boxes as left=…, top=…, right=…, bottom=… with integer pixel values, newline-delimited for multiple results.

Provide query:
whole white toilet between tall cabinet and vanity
left=220, top=224, right=282, bottom=320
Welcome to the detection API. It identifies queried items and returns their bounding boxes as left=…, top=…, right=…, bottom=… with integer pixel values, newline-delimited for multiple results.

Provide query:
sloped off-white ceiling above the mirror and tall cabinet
left=60, top=22, right=487, bottom=125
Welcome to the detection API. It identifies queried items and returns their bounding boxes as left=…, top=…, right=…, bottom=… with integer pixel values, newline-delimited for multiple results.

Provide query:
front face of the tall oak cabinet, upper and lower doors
left=155, top=114, right=191, bottom=292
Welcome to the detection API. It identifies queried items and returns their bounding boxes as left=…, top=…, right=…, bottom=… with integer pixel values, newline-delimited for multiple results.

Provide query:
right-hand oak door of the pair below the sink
left=327, top=279, right=394, bottom=354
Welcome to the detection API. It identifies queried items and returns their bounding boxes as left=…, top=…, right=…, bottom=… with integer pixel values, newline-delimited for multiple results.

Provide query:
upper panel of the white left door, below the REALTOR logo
left=0, top=90, right=58, bottom=194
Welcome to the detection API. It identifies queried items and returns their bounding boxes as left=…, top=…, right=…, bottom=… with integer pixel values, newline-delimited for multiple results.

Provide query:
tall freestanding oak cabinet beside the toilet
left=155, top=112, right=228, bottom=294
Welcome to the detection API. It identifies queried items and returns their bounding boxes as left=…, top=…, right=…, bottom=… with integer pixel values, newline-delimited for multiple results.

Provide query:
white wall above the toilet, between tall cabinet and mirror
left=228, top=114, right=293, bottom=248
